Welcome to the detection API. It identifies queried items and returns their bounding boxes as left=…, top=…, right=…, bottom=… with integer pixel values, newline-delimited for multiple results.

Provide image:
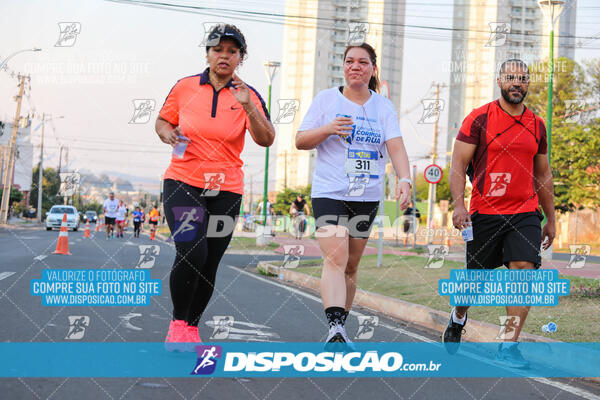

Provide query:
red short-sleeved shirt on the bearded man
left=456, top=100, right=548, bottom=214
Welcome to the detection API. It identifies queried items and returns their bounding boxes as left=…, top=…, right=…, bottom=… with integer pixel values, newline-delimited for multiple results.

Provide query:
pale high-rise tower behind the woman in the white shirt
left=273, top=0, right=405, bottom=190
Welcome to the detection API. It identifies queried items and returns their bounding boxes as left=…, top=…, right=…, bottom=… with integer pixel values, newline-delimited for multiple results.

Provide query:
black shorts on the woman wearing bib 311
left=312, top=197, right=379, bottom=239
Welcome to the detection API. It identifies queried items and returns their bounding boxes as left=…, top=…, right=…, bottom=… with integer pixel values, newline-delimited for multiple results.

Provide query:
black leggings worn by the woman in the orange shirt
left=164, top=179, right=242, bottom=325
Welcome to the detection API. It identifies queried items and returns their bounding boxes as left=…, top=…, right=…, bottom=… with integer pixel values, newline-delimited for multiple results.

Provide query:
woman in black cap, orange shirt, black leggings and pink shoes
left=156, top=24, right=275, bottom=351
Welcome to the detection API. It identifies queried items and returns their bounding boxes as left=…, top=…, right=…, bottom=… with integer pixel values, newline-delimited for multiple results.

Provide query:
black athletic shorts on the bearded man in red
left=466, top=211, right=544, bottom=269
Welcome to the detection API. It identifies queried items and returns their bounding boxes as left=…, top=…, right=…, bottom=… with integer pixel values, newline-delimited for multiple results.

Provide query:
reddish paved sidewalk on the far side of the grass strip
left=272, top=236, right=600, bottom=279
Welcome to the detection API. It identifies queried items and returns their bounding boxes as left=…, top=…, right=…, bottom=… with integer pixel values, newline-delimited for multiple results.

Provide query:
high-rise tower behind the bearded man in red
left=446, top=0, right=576, bottom=161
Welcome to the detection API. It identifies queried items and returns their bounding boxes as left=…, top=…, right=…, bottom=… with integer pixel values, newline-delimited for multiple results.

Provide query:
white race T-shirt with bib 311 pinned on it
left=298, top=87, right=402, bottom=201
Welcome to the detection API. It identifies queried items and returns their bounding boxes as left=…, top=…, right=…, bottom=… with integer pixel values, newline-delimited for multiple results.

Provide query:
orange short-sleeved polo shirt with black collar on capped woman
left=159, top=68, right=270, bottom=194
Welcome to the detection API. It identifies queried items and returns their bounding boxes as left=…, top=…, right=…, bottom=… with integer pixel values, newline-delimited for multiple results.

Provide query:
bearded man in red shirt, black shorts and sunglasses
left=443, top=59, right=556, bottom=368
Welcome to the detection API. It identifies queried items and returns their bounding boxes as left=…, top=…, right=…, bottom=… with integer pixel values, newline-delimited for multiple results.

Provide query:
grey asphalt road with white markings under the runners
left=0, top=228, right=600, bottom=400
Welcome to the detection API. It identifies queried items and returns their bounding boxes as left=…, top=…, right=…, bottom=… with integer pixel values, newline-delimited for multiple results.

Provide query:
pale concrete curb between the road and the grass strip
left=257, top=261, right=600, bottom=383
